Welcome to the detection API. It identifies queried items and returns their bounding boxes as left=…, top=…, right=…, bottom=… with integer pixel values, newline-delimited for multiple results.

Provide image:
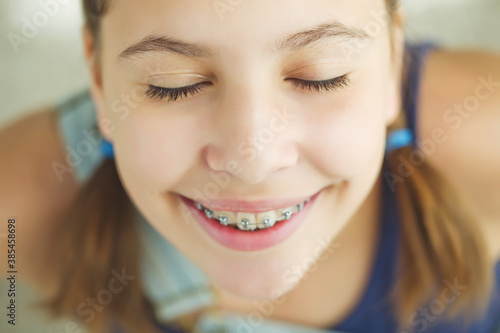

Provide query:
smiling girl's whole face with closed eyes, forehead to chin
left=92, top=0, right=400, bottom=299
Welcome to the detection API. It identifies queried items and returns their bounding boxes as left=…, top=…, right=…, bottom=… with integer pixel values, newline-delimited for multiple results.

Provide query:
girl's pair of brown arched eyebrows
left=118, top=21, right=372, bottom=59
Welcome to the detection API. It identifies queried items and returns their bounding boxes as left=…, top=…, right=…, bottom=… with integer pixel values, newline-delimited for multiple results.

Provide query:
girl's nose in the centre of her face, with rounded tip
left=205, top=84, right=299, bottom=184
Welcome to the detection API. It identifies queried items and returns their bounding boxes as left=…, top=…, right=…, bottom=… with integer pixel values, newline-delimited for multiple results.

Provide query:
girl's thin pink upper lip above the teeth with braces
left=182, top=191, right=321, bottom=213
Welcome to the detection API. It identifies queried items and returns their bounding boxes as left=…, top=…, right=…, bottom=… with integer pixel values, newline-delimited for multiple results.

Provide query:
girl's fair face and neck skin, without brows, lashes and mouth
left=85, top=0, right=402, bottom=326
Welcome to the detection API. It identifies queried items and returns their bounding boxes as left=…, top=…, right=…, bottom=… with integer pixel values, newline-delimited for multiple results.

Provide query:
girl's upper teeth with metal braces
left=195, top=199, right=310, bottom=231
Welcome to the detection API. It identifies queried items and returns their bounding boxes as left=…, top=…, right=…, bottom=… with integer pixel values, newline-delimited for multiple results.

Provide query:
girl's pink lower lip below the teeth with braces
left=180, top=191, right=322, bottom=251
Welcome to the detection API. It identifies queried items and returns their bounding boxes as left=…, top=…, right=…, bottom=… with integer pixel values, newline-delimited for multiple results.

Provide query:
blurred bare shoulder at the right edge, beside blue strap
left=418, top=50, right=500, bottom=260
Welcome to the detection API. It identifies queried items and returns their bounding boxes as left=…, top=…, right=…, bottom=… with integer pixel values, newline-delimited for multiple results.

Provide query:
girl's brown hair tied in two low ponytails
left=42, top=0, right=492, bottom=332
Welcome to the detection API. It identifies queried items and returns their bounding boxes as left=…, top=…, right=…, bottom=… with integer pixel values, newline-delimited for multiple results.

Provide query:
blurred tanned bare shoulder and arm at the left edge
left=0, top=107, right=78, bottom=294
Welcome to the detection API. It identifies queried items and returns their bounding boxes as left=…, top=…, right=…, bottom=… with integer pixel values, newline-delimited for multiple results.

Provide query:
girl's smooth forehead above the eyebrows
left=102, top=0, right=385, bottom=59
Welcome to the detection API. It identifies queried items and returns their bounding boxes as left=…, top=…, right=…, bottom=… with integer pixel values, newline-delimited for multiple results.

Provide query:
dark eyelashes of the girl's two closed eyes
left=146, top=74, right=350, bottom=102
